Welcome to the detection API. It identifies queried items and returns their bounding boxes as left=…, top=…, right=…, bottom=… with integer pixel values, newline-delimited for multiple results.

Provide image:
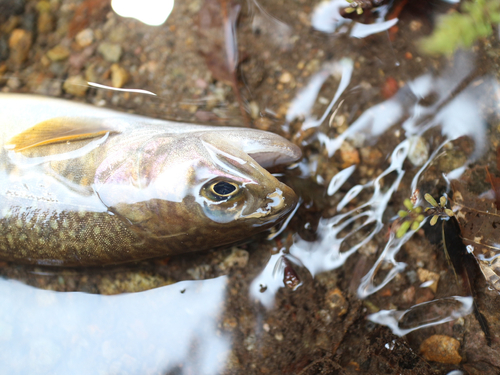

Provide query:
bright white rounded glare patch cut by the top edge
left=111, top=0, right=174, bottom=26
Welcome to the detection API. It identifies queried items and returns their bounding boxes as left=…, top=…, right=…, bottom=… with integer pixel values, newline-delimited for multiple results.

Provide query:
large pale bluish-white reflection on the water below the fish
left=0, top=276, right=231, bottom=375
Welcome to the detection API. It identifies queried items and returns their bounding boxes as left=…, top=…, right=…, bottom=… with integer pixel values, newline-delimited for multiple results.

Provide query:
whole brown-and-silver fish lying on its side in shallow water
left=0, top=93, right=301, bottom=267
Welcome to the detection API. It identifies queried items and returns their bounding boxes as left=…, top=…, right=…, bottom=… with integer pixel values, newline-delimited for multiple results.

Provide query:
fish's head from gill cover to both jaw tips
left=98, top=129, right=300, bottom=255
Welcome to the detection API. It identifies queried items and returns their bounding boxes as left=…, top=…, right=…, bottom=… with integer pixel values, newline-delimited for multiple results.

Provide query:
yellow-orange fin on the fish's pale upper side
left=5, top=117, right=120, bottom=151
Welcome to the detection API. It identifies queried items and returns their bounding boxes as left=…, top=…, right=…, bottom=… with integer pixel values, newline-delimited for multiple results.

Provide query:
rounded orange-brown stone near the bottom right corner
left=420, top=335, right=462, bottom=365
